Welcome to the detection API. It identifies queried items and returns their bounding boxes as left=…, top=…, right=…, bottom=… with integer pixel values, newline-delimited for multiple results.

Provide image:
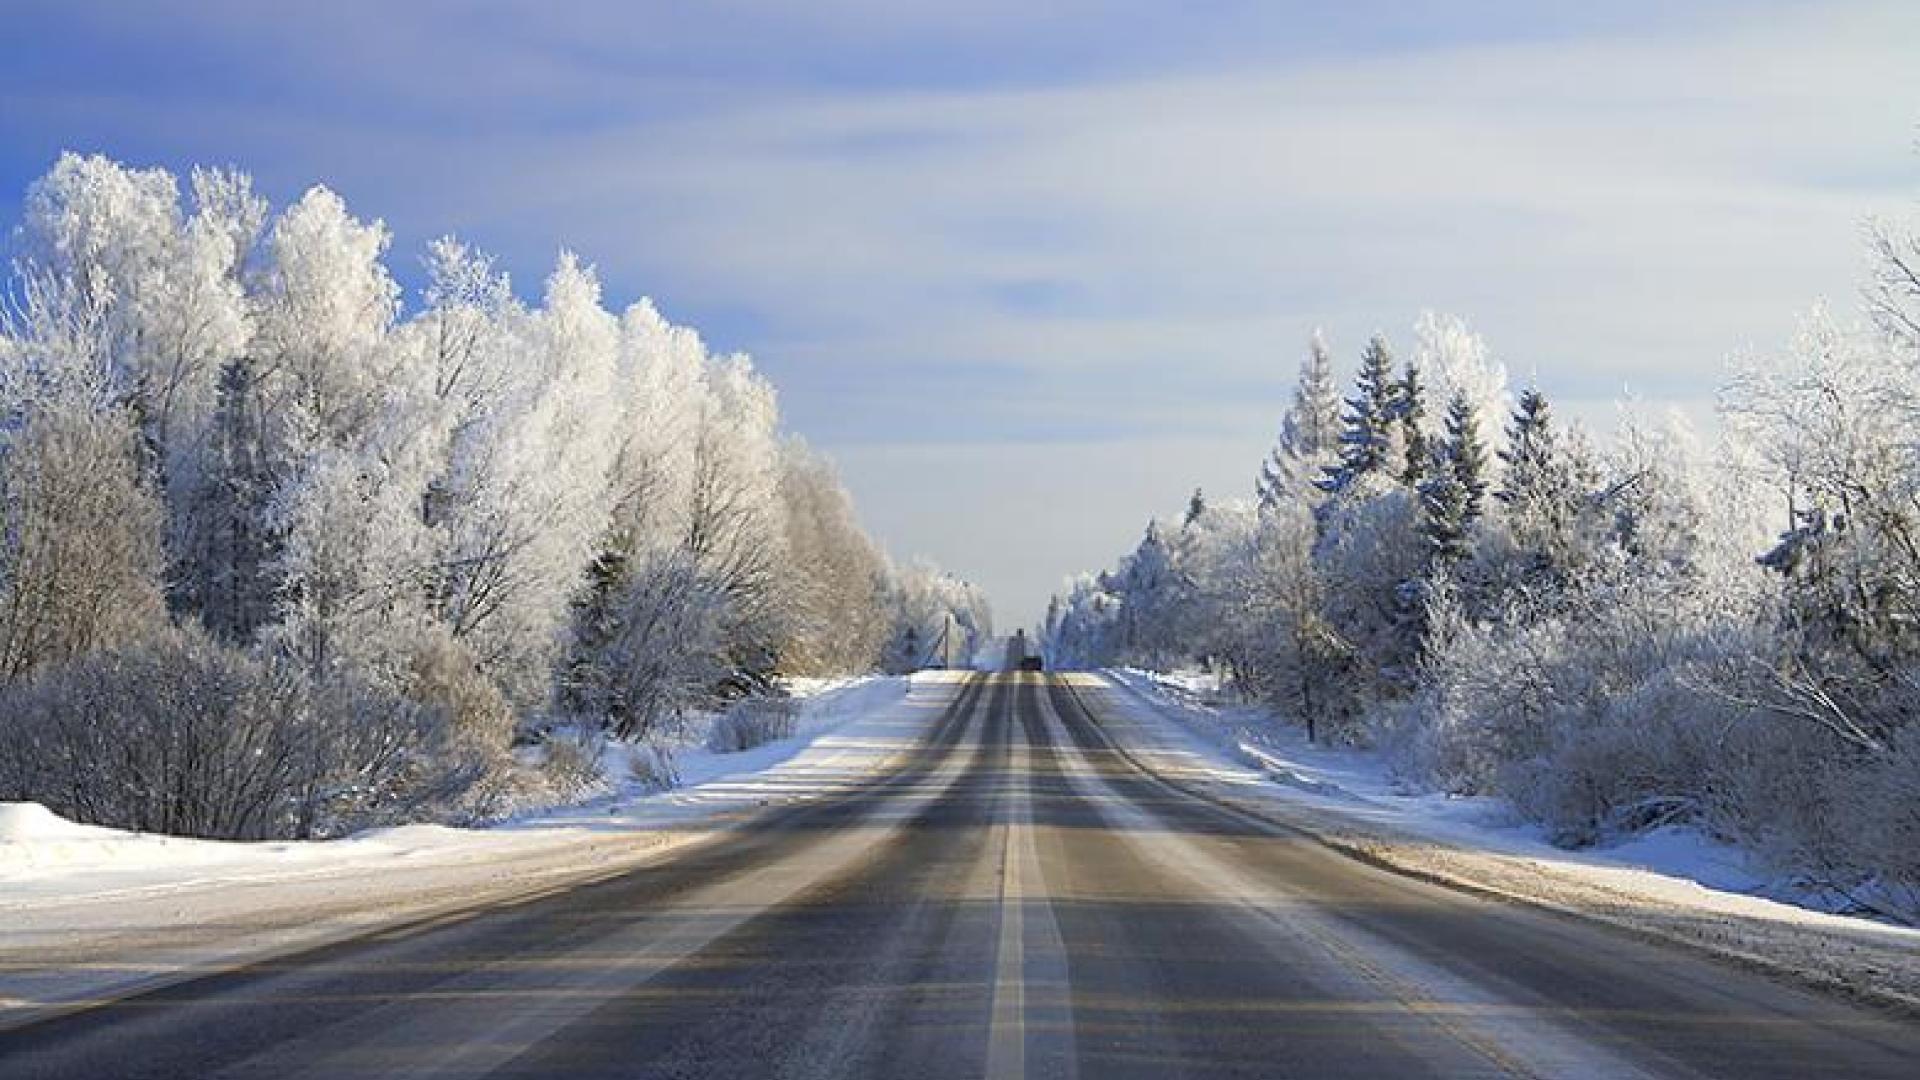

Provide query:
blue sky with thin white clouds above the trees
left=0, top=0, right=1920, bottom=621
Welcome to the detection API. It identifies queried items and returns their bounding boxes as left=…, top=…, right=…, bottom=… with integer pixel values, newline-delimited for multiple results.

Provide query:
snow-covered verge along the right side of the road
left=1069, top=671, right=1920, bottom=1009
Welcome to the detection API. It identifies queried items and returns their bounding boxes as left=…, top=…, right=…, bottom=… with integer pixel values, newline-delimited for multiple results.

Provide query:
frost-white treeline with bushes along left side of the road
left=0, top=156, right=991, bottom=838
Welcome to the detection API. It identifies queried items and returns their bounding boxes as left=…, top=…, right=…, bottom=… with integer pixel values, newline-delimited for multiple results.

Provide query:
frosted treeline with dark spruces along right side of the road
left=1044, top=197, right=1920, bottom=919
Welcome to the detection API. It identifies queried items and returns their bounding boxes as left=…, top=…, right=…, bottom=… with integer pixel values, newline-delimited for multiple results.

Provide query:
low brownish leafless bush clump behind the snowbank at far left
left=0, top=630, right=474, bottom=840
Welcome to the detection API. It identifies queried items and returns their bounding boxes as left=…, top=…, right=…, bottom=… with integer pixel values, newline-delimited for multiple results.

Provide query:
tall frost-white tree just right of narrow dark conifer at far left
left=252, top=186, right=432, bottom=680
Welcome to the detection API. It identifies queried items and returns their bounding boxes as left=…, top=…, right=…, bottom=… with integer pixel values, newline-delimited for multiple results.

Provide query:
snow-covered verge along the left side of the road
left=0, top=673, right=962, bottom=1026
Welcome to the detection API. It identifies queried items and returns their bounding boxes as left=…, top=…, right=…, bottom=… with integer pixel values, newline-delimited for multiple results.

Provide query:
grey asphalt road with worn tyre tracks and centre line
left=0, top=675, right=1920, bottom=1080
